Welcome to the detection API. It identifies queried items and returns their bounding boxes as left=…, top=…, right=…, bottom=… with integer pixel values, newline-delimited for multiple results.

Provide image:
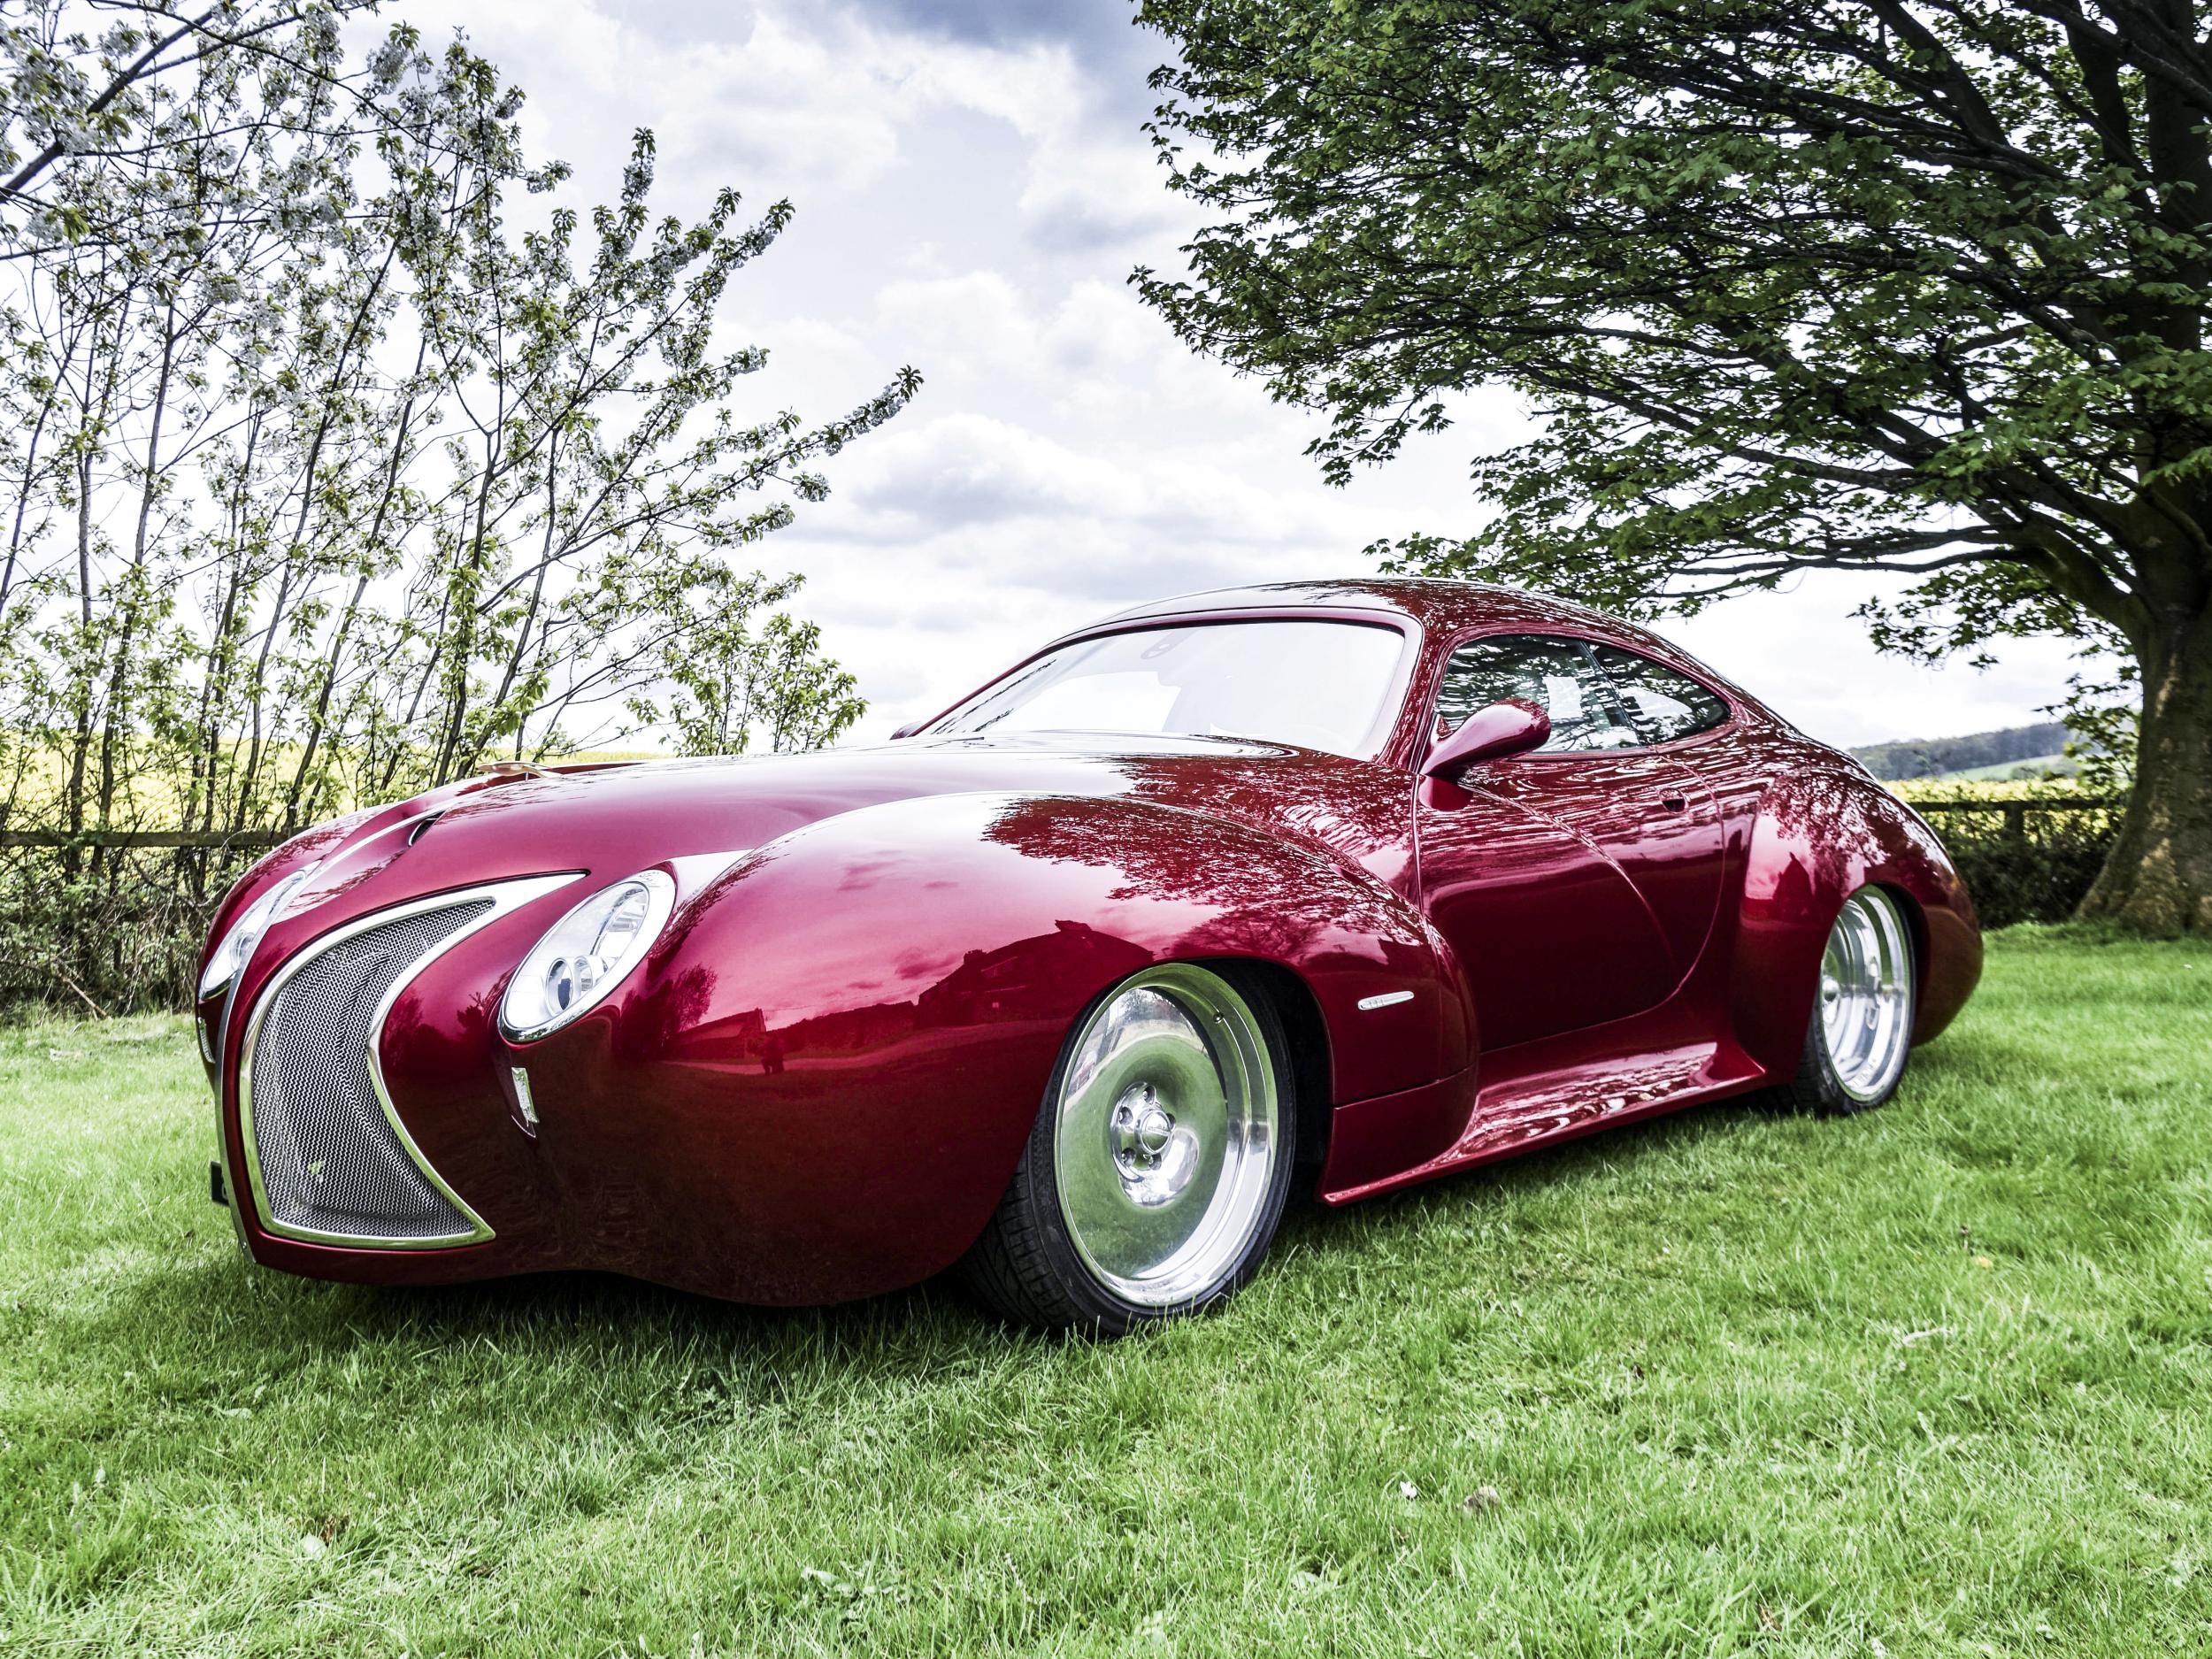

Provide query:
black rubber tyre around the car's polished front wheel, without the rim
left=960, top=964, right=1299, bottom=1336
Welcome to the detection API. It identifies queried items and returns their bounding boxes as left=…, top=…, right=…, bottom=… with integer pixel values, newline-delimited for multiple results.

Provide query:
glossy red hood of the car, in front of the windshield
left=288, top=733, right=1409, bottom=920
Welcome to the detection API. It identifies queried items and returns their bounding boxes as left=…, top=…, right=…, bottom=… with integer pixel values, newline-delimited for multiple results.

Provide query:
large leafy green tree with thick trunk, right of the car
left=1135, top=0, right=2212, bottom=932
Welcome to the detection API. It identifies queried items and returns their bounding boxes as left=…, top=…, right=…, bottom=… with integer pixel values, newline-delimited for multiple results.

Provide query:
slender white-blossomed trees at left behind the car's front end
left=0, top=0, right=920, bottom=1000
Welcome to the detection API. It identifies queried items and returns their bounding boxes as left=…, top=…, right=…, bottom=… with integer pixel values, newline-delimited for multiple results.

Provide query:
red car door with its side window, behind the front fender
left=1414, top=635, right=1721, bottom=1048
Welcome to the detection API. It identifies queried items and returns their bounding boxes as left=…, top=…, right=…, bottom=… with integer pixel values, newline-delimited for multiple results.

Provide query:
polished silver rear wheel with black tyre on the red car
left=1783, top=887, right=1914, bottom=1113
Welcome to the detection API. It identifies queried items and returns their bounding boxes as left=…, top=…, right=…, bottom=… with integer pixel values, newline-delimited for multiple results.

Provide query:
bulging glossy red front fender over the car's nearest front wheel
left=511, top=795, right=1451, bottom=1301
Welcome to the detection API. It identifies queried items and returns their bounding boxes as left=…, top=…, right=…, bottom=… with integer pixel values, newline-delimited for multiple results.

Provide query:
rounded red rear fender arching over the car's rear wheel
left=1730, top=768, right=1982, bottom=1078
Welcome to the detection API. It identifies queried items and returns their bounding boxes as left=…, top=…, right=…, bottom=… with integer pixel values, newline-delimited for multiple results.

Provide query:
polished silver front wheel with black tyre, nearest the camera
left=964, top=963, right=1296, bottom=1336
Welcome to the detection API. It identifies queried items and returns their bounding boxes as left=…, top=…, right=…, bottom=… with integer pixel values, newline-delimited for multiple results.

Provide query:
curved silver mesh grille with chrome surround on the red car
left=239, top=874, right=578, bottom=1250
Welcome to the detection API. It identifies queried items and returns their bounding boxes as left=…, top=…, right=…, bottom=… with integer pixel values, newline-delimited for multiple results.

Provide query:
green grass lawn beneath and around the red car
left=0, top=932, right=2212, bottom=1657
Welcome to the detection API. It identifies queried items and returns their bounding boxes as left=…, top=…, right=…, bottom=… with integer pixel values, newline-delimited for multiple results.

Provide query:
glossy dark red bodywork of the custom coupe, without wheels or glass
left=199, top=582, right=1982, bottom=1303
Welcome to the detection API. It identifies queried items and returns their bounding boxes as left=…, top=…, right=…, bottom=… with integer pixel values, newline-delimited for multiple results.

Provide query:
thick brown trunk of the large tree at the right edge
left=2079, top=609, right=2212, bottom=933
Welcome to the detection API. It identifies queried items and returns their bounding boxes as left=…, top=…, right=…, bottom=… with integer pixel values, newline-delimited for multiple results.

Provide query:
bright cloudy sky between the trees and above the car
left=416, top=0, right=2066, bottom=743
